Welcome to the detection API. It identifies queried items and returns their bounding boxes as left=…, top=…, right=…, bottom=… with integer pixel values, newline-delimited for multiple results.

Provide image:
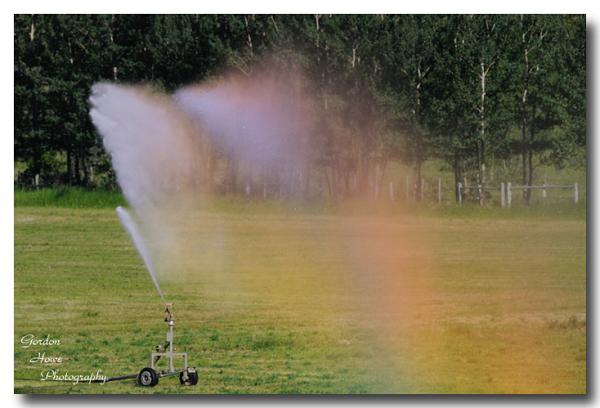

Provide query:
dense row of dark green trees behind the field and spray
left=14, top=15, right=586, bottom=201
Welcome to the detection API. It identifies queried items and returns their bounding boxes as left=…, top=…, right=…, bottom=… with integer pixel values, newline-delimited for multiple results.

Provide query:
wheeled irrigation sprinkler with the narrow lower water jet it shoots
left=95, top=207, right=198, bottom=387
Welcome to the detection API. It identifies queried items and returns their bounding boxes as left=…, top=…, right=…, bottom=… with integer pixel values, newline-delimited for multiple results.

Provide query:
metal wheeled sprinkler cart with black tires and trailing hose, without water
left=99, top=303, right=198, bottom=387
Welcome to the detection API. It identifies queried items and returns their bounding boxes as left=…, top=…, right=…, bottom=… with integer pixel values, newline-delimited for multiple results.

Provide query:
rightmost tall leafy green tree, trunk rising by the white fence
left=513, top=15, right=585, bottom=203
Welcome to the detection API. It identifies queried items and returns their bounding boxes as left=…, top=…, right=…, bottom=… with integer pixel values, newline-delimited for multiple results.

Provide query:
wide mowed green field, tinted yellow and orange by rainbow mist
left=14, top=207, right=586, bottom=394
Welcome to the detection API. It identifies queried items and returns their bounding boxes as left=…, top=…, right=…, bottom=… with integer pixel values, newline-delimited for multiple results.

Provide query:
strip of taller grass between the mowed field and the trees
left=14, top=187, right=587, bottom=220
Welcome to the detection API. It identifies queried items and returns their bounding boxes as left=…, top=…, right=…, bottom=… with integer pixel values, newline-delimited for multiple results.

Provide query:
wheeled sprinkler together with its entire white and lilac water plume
left=90, top=75, right=312, bottom=387
